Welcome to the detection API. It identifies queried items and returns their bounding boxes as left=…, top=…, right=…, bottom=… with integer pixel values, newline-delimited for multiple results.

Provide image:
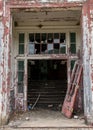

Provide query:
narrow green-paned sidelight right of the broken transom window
left=70, top=32, right=76, bottom=54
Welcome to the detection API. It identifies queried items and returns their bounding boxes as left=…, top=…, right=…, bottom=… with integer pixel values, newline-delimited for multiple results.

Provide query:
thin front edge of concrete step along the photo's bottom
left=0, top=127, right=93, bottom=130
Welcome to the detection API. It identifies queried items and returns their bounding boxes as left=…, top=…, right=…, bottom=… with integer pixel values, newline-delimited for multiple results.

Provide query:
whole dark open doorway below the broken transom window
left=27, top=60, right=67, bottom=110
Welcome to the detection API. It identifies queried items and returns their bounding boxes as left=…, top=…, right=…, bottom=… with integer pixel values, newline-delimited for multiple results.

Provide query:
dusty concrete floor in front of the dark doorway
left=8, top=109, right=86, bottom=127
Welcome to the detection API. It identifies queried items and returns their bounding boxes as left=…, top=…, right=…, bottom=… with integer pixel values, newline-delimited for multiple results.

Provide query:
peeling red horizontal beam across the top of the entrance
left=7, top=0, right=86, bottom=8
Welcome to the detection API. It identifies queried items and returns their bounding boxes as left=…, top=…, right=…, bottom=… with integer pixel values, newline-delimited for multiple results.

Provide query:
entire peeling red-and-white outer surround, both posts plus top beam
left=0, top=0, right=93, bottom=126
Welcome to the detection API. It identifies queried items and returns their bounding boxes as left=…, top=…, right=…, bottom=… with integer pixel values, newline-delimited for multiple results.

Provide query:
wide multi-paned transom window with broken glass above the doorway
left=28, top=33, right=66, bottom=54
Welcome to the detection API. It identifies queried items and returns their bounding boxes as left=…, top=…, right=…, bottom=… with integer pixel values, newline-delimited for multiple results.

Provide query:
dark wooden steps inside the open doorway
left=27, top=79, right=67, bottom=110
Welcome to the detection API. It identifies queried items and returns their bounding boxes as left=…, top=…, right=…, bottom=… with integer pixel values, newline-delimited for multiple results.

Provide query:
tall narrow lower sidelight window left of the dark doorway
left=18, top=61, right=24, bottom=93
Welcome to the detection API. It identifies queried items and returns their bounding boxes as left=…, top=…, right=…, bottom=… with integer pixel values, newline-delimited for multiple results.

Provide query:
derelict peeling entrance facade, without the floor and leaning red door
left=0, top=0, right=93, bottom=124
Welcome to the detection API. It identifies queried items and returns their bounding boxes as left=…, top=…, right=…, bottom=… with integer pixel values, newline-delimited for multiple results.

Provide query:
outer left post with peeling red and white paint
left=0, top=0, right=11, bottom=124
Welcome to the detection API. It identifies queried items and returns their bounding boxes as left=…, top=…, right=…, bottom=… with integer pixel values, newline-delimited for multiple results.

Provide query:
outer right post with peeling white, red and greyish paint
left=82, top=0, right=93, bottom=124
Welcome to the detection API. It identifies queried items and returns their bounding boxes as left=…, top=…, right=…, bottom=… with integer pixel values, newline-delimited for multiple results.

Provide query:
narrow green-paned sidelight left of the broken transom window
left=19, top=33, right=24, bottom=54
